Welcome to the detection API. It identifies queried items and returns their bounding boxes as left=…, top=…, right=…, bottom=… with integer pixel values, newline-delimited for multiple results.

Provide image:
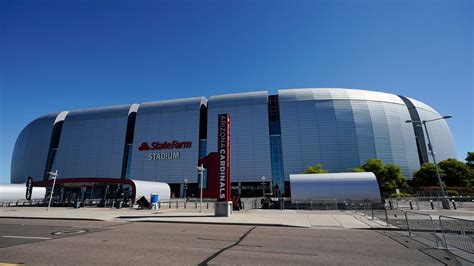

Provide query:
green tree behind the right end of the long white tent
left=352, top=159, right=407, bottom=196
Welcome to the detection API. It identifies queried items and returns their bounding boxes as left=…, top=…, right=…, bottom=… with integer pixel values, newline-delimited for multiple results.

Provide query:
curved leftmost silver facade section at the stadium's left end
left=11, top=113, right=58, bottom=183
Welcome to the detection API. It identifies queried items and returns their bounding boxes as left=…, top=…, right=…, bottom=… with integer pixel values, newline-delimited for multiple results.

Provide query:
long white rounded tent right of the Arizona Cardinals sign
left=290, top=172, right=381, bottom=203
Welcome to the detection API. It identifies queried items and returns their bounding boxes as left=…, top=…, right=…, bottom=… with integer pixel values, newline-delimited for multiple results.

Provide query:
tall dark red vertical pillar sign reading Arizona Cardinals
left=215, top=114, right=232, bottom=217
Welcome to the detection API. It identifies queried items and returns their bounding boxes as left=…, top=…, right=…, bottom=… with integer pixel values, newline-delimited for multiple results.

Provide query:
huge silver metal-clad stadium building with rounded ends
left=11, top=88, right=456, bottom=201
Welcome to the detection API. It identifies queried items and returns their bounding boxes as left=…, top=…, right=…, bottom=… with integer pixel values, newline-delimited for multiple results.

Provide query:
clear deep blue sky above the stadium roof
left=0, top=0, right=474, bottom=183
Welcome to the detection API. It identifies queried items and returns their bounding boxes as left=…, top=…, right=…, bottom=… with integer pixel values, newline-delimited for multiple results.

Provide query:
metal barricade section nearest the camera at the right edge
left=439, top=215, right=474, bottom=254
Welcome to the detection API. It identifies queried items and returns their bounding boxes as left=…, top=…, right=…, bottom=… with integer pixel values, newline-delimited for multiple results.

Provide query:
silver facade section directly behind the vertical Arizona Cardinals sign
left=207, top=92, right=272, bottom=182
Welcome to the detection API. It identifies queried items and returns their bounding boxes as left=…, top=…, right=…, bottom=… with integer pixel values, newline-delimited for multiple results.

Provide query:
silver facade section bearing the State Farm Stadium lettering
left=130, top=97, right=206, bottom=183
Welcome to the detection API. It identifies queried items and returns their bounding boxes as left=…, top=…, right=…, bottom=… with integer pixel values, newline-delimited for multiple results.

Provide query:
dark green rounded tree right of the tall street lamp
left=438, top=159, right=472, bottom=186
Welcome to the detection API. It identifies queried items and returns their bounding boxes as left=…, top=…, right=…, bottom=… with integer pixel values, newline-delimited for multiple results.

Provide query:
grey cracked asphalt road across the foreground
left=0, top=218, right=459, bottom=265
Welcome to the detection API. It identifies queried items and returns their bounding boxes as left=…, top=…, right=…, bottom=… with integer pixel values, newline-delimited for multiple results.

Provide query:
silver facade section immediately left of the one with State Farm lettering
left=52, top=105, right=130, bottom=178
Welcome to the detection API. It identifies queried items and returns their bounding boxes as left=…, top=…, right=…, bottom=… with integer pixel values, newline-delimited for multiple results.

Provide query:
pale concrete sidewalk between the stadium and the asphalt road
left=0, top=207, right=382, bottom=229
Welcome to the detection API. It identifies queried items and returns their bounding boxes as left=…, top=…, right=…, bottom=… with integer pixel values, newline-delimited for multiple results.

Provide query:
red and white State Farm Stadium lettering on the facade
left=138, top=140, right=193, bottom=161
